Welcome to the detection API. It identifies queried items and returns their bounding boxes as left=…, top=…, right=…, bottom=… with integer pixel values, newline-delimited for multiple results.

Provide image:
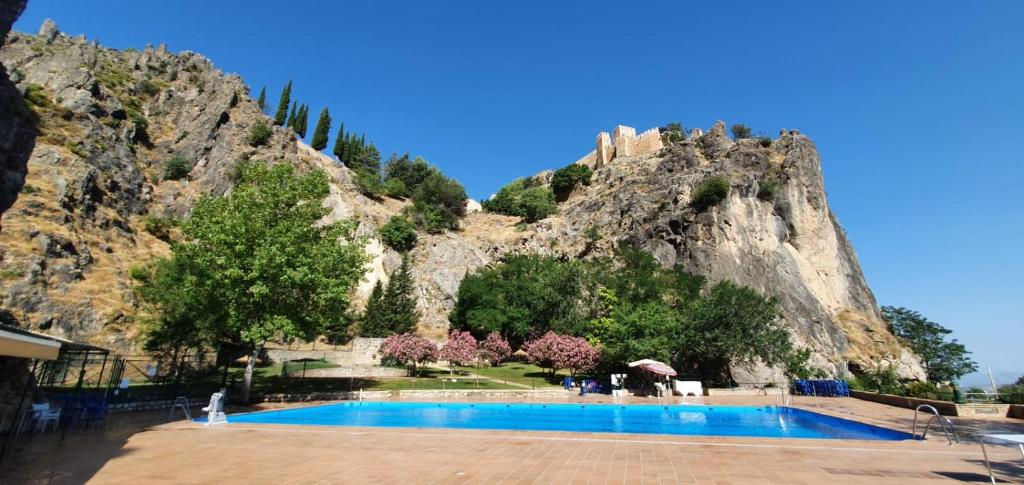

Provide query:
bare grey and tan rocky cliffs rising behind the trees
left=0, top=21, right=920, bottom=374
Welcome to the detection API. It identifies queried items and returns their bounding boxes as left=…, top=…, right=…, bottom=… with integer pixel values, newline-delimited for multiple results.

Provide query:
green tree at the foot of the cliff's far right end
left=882, top=306, right=978, bottom=382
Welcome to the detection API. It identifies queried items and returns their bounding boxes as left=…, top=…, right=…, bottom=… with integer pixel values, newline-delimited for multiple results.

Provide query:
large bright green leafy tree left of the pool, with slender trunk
left=140, top=163, right=368, bottom=400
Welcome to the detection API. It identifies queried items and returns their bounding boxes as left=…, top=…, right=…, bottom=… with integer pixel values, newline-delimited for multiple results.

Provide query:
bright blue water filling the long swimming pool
left=214, top=402, right=910, bottom=441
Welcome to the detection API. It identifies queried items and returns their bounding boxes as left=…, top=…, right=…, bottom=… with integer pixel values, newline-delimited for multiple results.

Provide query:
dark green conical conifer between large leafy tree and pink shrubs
left=359, top=255, right=420, bottom=337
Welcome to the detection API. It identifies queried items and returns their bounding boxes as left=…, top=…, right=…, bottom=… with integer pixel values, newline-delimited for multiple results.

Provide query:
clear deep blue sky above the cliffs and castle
left=16, top=0, right=1024, bottom=384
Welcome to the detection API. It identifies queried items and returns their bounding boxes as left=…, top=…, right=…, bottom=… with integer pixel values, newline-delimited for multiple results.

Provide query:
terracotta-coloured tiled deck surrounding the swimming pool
left=0, top=396, right=1024, bottom=485
